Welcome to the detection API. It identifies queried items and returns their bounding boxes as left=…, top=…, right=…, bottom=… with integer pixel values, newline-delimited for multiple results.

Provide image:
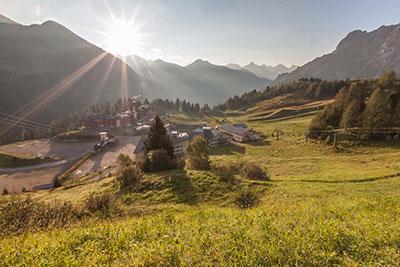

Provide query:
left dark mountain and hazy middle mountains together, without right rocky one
left=0, top=16, right=270, bottom=129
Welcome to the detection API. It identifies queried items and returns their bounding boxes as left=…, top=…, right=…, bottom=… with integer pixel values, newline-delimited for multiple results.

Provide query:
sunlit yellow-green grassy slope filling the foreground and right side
left=0, top=100, right=400, bottom=266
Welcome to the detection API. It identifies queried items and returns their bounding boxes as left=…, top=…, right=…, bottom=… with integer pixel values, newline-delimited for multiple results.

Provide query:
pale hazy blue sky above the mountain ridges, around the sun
left=0, top=0, right=400, bottom=65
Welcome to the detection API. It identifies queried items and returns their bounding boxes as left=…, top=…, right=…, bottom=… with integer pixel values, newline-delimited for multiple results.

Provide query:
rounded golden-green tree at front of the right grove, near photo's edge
left=363, top=87, right=392, bottom=129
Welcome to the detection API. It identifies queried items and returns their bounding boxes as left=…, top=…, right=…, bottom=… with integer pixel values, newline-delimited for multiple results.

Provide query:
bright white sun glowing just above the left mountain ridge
left=104, top=19, right=144, bottom=56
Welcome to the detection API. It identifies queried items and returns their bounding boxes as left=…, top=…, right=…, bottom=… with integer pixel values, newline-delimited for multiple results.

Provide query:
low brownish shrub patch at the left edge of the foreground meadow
left=0, top=195, right=80, bottom=235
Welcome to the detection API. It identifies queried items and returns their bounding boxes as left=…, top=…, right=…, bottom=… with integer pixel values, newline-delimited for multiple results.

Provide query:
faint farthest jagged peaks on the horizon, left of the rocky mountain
left=226, top=62, right=298, bottom=80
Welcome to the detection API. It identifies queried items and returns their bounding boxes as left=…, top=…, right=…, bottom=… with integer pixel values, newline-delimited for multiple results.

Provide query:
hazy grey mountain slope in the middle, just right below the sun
left=124, top=56, right=270, bottom=104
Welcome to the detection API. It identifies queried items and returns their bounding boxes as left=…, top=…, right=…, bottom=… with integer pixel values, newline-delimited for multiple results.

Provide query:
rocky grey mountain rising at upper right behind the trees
left=274, top=24, right=400, bottom=85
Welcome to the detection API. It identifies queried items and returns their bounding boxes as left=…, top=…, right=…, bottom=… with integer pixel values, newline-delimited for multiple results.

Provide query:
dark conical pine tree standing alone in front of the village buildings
left=144, top=116, right=174, bottom=158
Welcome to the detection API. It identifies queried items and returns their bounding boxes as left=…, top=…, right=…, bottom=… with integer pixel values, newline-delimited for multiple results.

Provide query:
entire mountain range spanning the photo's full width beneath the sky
left=0, top=15, right=400, bottom=133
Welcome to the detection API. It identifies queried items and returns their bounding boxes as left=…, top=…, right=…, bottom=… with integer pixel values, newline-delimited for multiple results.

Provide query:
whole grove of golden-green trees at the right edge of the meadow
left=310, top=71, right=400, bottom=132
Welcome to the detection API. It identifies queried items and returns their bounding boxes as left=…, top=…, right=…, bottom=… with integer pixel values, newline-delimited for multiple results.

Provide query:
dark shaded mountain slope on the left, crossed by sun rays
left=0, top=18, right=159, bottom=126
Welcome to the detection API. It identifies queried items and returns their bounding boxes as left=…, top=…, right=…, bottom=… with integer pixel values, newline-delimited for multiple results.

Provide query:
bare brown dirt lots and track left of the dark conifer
left=0, top=136, right=144, bottom=192
